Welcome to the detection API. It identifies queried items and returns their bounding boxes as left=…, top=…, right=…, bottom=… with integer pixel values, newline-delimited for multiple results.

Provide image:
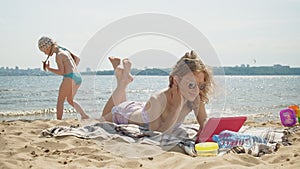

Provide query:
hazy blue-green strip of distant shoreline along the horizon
left=0, top=65, right=300, bottom=76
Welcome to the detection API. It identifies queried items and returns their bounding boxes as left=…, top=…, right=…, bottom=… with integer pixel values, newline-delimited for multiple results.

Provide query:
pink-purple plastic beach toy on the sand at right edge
left=279, top=108, right=297, bottom=126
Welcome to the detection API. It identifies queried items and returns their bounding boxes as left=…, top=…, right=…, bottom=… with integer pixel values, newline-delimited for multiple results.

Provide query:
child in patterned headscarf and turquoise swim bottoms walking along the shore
left=38, top=37, right=89, bottom=120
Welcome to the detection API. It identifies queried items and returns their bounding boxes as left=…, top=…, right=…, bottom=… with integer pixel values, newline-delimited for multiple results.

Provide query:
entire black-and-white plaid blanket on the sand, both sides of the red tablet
left=40, top=122, right=295, bottom=156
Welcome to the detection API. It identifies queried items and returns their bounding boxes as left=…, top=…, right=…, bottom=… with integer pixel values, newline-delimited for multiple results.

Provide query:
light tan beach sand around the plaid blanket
left=0, top=119, right=300, bottom=169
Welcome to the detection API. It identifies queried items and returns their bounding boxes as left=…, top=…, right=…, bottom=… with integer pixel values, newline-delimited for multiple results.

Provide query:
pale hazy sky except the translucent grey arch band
left=0, top=0, right=300, bottom=69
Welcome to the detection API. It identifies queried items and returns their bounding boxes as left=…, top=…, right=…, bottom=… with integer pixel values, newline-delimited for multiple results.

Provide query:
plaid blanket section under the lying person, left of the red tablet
left=40, top=122, right=197, bottom=156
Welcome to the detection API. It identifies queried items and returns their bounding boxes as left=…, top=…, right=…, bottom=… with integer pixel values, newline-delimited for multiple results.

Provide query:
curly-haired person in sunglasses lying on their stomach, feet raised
left=102, top=51, right=213, bottom=132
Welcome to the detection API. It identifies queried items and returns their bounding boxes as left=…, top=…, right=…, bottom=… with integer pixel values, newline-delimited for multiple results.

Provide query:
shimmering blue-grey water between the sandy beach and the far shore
left=0, top=76, right=300, bottom=121
